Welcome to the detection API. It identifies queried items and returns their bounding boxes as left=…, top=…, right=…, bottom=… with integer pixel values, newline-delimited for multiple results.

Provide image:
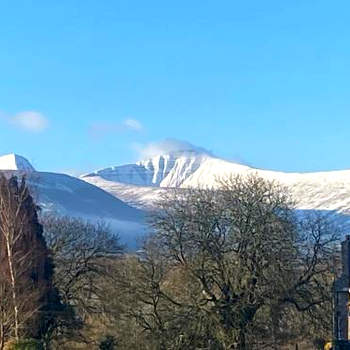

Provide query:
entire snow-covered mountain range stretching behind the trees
left=4, top=147, right=350, bottom=249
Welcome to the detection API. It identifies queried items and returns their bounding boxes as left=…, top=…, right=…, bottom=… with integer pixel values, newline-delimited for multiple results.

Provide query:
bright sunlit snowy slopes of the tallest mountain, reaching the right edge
left=81, top=151, right=350, bottom=219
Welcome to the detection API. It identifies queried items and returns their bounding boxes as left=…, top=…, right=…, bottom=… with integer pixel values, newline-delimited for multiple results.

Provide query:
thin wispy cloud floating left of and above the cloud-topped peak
left=89, top=118, right=143, bottom=138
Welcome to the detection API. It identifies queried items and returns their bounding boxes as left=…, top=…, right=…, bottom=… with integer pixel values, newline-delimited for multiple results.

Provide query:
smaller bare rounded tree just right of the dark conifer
left=41, top=215, right=123, bottom=342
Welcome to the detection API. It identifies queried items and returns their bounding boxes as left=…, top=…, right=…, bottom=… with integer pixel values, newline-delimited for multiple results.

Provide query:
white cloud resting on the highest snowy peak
left=131, top=139, right=212, bottom=159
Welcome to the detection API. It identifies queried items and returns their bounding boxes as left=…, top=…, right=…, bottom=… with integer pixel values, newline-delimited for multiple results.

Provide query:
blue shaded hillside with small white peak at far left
left=0, top=154, right=145, bottom=246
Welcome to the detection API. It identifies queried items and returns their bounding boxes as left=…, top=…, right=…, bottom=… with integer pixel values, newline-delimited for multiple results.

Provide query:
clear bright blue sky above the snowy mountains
left=0, top=0, right=350, bottom=173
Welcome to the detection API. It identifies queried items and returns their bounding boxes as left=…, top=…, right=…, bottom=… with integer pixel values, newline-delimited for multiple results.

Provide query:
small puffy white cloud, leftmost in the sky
left=10, top=111, right=49, bottom=132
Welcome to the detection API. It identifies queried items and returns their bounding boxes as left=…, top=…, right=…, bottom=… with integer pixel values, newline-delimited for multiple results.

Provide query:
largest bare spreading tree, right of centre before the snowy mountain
left=147, top=176, right=337, bottom=349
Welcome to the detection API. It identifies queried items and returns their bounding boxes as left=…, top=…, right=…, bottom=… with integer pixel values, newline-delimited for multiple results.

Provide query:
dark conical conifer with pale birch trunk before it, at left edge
left=0, top=175, right=60, bottom=342
